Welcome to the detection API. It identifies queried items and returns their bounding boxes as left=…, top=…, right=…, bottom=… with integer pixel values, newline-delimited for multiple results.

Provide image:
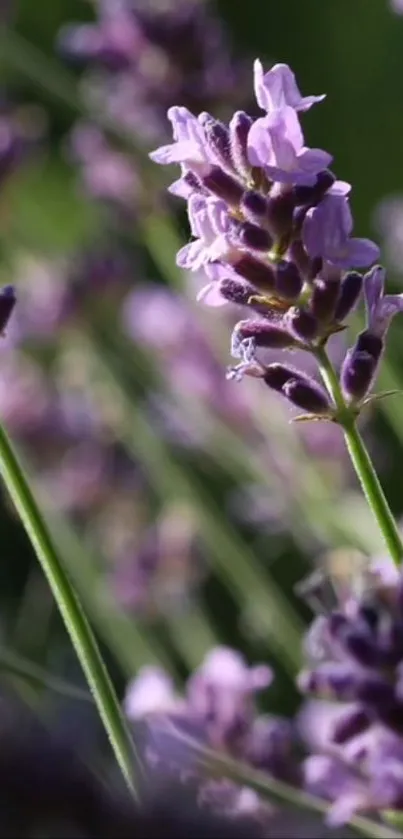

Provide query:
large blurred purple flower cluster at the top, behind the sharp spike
left=59, top=0, right=243, bottom=137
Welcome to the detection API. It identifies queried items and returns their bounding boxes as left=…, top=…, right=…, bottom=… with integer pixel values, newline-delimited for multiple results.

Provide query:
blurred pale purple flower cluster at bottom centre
left=125, top=647, right=299, bottom=816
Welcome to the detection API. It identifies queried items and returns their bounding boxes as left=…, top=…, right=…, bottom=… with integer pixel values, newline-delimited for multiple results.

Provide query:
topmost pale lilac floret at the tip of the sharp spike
left=253, top=59, right=326, bottom=113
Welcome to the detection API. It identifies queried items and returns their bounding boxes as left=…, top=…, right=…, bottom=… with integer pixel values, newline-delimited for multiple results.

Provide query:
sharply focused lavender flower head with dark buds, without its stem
left=150, top=61, right=403, bottom=419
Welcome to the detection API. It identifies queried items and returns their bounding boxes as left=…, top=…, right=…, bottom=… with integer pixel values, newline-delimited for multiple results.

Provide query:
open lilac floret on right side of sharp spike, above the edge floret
left=303, top=194, right=379, bottom=268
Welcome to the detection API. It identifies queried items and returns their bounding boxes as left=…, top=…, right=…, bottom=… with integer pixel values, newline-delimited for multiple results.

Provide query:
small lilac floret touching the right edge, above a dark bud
left=364, top=265, right=403, bottom=338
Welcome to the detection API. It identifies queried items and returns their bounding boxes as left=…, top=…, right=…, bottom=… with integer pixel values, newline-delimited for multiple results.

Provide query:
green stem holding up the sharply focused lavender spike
left=315, top=347, right=403, bottom=567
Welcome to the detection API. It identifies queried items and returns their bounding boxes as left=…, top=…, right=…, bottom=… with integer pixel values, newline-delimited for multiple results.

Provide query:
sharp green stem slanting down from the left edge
left=0, top=424, right=140, bottom=794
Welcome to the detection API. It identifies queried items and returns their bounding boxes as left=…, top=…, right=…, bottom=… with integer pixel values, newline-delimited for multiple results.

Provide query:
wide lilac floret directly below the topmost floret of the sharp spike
left=248, top=106, right=332, bottom=186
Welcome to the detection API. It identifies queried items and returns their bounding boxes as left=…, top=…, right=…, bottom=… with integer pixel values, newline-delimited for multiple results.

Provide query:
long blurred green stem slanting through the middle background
left=77, top=336, right=303, bottom=672
